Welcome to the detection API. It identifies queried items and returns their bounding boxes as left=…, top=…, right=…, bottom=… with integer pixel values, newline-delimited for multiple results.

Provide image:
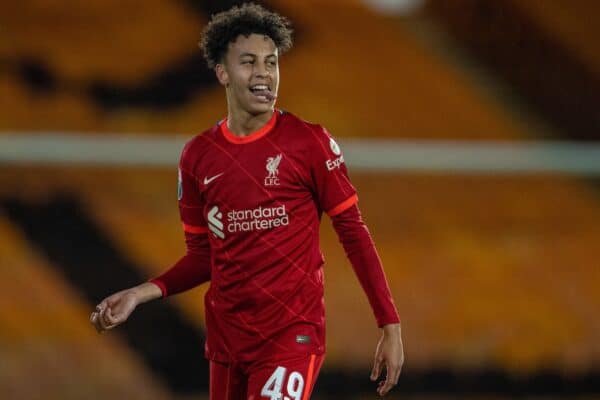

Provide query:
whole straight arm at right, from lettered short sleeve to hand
left=306, top=125, right=404, bottom=395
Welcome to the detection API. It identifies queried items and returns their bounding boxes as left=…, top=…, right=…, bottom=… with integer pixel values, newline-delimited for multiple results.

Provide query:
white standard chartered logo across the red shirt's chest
left=207, top=205, right=290, bottom=239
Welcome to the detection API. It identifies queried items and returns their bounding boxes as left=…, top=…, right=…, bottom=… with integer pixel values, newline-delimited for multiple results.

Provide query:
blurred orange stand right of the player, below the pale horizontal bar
left=323, top=175, right=600, bottom=374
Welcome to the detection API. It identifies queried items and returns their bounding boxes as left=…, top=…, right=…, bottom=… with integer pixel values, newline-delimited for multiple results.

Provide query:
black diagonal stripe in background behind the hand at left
left=0, top=196, right=208, bottom=394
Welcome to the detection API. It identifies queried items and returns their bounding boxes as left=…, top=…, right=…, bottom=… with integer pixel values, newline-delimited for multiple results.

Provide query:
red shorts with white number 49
left=210, top=354, right=324, bottom=400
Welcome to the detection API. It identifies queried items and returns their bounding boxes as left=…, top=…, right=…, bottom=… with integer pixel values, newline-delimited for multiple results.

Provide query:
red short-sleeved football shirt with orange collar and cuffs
left=179, top=110, right=394, bottom=361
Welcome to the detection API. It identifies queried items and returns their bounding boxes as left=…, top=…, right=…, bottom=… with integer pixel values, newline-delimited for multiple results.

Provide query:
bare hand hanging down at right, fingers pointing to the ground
left=371, top=324, right=404, bottom=396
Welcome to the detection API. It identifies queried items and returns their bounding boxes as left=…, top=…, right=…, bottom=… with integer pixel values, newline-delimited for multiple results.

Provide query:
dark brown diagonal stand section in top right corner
left=427, top=0, right=600, bottom=140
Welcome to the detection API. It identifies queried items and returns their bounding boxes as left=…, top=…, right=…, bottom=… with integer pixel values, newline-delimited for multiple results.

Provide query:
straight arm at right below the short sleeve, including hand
left=330, top=204, right=404, bottom=396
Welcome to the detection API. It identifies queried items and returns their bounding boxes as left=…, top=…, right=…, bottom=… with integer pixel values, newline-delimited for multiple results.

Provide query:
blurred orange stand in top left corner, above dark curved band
left=0, top=0, right=202, bottom=83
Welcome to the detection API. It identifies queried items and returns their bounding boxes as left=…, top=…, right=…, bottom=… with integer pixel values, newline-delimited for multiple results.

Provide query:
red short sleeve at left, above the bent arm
left=177, top=150, right=208, bottom=233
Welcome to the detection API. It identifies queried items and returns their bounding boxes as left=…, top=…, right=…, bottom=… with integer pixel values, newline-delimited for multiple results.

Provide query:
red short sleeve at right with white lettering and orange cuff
left=310, top=126, right=358, bottom=217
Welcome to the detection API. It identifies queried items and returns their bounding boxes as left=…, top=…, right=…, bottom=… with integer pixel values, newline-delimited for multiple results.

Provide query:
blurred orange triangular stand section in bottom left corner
left=0, top=211, right=169, bottom=400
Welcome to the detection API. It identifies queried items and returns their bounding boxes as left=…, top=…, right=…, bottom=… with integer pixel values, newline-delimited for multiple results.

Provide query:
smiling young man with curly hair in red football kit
left=91, top=4, right=404, bottom=400
